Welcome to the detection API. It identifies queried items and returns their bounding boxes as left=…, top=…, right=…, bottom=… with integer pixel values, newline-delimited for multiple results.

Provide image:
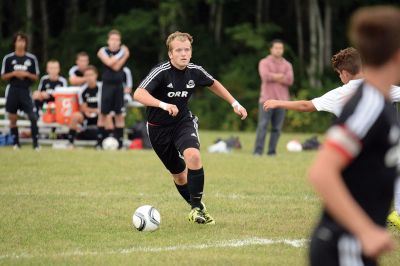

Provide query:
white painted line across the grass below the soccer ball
left=0, top=237, right=308, bottom=260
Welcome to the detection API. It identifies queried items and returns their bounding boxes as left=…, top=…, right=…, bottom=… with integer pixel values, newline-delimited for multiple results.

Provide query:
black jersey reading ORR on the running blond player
left=139, top=62, right=214, bottom=125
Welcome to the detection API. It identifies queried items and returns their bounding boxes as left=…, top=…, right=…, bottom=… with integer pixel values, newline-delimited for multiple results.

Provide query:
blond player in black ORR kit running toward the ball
left=134, top=32, right=247, bottom=224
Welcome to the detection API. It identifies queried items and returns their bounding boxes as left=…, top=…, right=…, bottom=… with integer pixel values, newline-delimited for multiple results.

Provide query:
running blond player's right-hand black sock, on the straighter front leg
left=188, top=167, right=204, bottom=208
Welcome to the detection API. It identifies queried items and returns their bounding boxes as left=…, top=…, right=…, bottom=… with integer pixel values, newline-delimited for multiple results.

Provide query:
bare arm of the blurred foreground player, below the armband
left=309, top=145, right=394, bottom=258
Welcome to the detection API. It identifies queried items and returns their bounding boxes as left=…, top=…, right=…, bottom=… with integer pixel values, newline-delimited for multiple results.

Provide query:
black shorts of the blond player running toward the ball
left=147, top=116, right=200, bottom=174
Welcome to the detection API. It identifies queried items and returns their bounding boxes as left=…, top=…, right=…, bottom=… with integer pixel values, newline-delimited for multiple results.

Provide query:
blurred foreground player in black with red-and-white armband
left=309, top=7, right=400, bottom=266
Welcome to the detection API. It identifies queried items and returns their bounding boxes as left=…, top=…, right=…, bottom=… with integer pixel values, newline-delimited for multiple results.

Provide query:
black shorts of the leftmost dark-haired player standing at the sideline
left=6, top=86, right=33, bottom=114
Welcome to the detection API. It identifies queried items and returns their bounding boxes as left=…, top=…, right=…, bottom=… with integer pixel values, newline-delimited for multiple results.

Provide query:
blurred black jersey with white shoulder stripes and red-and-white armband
left=322, top=84, right=400, bottom=229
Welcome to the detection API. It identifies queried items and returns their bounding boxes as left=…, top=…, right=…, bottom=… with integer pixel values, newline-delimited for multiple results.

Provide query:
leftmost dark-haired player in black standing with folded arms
left=1, top=33, right=40, bottom=150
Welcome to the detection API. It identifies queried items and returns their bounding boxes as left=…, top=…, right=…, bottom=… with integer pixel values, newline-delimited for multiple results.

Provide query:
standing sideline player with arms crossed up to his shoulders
left=97, top=30, right=129, bottom=148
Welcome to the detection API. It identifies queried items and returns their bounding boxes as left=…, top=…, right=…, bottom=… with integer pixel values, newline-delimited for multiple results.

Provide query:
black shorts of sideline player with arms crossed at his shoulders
left=100, top=81, right=124, bottom=114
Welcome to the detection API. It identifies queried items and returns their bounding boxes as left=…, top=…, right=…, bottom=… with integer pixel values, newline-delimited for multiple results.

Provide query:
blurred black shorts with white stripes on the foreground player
left=309, top=220, right=377, bottom=266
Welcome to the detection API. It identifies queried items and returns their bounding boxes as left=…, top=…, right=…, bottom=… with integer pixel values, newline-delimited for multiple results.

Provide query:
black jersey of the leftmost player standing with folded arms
left=1, top=52, right=39, bottom=89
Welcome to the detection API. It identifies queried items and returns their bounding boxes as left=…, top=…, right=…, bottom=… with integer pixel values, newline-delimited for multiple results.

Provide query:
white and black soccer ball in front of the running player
left=132, top=205, right=161, bottom=231
